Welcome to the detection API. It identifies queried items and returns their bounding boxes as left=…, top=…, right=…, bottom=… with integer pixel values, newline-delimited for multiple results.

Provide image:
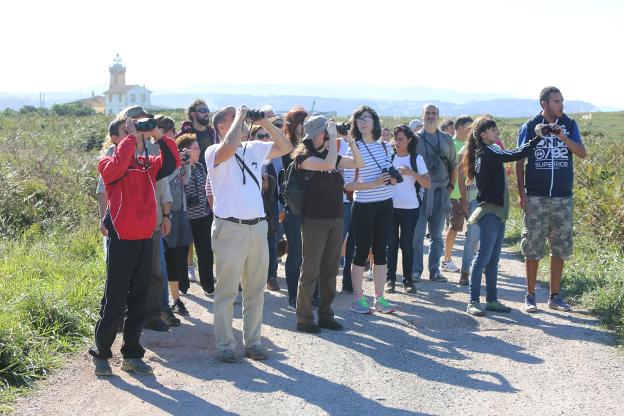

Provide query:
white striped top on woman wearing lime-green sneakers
left=344, top=140, right=392, bottom=203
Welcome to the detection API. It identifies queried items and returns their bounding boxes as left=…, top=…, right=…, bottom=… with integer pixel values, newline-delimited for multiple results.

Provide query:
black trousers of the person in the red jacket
left=89, top=231, right=153, bottom=359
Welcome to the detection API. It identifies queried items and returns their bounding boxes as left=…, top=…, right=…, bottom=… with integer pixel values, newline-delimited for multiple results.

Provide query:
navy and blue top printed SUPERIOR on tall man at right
left=518, top=114, right=582, bottom=197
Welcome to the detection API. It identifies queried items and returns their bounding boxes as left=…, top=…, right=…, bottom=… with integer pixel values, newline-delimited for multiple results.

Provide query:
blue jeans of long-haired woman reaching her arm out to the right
left=469, top=214, right=505, bottom=302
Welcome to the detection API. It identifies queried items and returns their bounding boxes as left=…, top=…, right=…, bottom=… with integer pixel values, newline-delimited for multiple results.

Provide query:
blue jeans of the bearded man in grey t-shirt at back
left=413, top=189, right=450, bottom=276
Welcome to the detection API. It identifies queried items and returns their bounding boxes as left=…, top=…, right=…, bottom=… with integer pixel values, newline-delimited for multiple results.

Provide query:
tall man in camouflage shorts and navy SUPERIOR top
left=516, top=87, right=587, bottom=312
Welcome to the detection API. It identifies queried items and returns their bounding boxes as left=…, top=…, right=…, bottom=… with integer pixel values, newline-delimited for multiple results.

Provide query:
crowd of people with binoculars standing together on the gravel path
left=90, top=87, right=586, bottom=375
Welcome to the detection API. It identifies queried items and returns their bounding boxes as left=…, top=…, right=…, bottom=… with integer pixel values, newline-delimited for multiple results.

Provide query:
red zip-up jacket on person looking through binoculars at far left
left=98, top=135, right=180, bottom=240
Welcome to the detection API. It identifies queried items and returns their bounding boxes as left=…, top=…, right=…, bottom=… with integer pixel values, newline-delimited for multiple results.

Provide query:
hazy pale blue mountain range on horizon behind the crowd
left=0, top=84, right=617, bottom=117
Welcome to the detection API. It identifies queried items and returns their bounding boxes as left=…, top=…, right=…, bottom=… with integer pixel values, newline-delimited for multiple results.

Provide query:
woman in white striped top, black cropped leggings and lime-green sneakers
left=345, top=106, right=396, bottom=313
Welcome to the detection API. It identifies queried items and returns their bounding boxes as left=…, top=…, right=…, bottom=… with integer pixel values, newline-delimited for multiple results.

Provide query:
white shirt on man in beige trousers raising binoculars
left=205, top=140, right=273, bottom=220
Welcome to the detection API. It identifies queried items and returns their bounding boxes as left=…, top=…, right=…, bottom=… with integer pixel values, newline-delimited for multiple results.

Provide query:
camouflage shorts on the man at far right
left=522, top=196, right=573, bottom=260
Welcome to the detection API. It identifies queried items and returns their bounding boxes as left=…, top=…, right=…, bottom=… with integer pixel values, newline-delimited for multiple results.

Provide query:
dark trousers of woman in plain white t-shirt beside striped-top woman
left=386, top=208, right=419, bottom=284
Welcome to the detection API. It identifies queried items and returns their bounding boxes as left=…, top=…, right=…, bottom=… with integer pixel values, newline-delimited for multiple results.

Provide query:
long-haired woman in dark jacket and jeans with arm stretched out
left=463, top=116, right=542, bottom=316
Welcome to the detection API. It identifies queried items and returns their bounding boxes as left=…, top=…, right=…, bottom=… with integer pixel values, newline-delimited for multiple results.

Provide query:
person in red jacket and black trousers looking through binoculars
left=89, top=113, right=180, bottom=376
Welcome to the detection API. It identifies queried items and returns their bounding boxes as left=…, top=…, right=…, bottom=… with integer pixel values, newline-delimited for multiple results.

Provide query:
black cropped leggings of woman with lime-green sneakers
left=351, top=199, right=392, bottom=267
